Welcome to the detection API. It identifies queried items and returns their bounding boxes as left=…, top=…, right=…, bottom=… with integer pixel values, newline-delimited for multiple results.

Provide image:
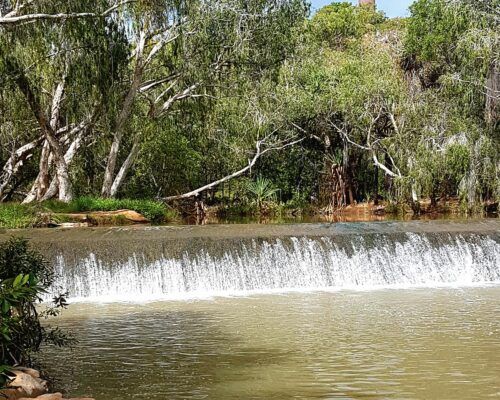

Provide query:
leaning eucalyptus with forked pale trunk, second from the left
left=97, top=0, right=307, bottom=196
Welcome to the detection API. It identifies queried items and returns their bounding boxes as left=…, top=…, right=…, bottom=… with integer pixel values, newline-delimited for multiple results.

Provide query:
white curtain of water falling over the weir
left=45, top=232, right=500, bottom=301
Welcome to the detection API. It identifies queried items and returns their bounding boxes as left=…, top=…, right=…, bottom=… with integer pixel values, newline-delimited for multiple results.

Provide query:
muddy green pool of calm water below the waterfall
left=43, top=286, right=500, bottom=400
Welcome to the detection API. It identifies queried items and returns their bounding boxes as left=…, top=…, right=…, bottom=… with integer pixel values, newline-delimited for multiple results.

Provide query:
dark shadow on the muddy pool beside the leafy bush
left=44, top=306, right=300, bottom=400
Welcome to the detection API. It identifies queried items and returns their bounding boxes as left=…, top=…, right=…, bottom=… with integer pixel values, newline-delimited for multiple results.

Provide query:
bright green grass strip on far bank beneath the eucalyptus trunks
left=0, top=197, right=177, bottom=229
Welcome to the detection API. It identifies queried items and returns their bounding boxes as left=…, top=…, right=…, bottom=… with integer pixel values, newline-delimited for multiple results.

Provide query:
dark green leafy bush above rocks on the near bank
left=0, top=238, right=72, bottom=372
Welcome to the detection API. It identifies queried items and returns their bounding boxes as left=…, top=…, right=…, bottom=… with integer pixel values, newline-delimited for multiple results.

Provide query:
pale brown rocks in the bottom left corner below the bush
left=0, top=368, right=94, bottom=400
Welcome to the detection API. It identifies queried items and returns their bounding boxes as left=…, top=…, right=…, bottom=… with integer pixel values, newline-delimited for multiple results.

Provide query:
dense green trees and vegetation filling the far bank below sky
left=0, top=0, right=500, bottom=220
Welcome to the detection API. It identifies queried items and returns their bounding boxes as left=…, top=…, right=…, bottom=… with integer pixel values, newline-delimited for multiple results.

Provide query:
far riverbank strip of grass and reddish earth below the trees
left=0, top=197, right=498, bottom=229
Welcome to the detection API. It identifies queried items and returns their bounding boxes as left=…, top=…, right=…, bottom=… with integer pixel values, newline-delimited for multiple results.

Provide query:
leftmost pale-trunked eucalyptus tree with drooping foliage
left=0, top=1, right=126, bottom=201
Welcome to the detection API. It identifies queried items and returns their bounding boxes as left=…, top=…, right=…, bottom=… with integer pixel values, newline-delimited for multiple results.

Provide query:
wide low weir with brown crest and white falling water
left=0, top=221, right=500, bottom=302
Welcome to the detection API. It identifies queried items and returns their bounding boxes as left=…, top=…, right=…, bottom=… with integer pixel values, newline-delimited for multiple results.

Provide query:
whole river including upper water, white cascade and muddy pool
left=0, top=220, right=500, bottom=400
